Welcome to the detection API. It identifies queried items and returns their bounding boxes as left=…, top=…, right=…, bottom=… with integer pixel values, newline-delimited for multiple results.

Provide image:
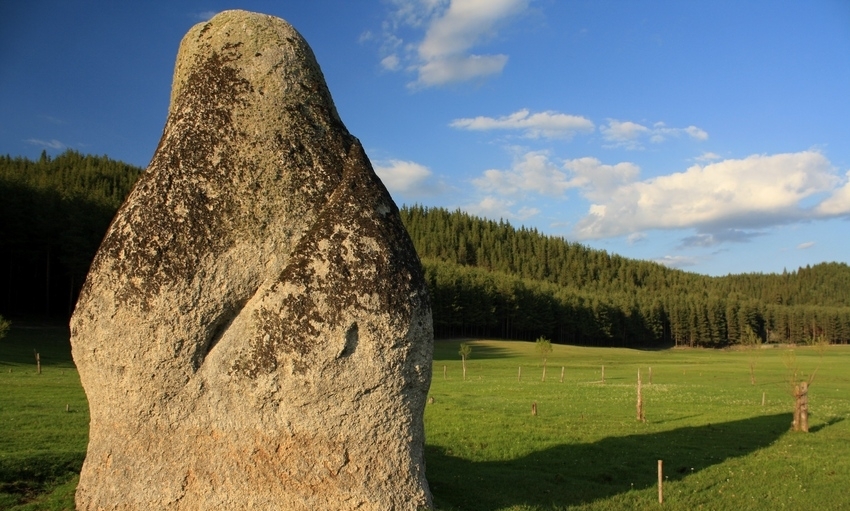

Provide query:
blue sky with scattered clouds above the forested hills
left=0, top=0, right=850, bottom=275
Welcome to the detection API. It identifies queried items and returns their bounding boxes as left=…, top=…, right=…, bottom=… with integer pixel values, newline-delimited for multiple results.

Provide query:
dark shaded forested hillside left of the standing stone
left=0, top=151, right=142, bottom=316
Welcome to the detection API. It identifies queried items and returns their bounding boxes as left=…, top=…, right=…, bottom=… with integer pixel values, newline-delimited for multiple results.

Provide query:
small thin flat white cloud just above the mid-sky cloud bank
left=449, top=109, right=595, bottom=138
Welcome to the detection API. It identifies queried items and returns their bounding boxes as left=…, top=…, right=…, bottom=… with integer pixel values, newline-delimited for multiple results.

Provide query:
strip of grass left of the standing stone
left=0, top=325, right=89, bottom=511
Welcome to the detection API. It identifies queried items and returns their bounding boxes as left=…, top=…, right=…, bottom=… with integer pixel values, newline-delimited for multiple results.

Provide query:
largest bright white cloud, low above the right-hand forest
left=576, top=151, right=840, bottom=244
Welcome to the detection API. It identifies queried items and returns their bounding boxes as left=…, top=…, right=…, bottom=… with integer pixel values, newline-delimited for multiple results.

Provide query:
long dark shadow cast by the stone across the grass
left=426, top=414, right=791, bottom=511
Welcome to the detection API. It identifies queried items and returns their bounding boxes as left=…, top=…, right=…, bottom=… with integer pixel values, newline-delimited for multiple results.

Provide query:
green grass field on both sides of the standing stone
left=0, top=328, right=850, bottom=511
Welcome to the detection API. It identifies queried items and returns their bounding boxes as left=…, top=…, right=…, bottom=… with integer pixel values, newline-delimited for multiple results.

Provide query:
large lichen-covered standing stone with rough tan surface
left=71, top=11, right=433, bottom=510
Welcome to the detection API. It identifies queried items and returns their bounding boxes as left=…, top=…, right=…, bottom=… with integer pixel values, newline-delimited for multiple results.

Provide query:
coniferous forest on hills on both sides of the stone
left=0, top=151, right=850, bottom=347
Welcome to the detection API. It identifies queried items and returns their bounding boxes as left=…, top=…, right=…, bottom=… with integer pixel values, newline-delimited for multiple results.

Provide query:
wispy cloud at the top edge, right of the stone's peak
left=380, top=0, right=529, bottom=88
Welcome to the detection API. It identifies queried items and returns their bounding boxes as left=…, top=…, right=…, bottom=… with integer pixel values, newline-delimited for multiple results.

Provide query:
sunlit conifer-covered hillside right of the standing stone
left=402, top=206, right=850, bottom=347
